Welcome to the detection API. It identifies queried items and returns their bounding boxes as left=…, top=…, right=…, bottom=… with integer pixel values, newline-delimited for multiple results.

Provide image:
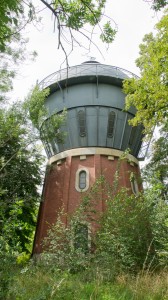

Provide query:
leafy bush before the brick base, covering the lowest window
left=42, top=212, right=92, bottom=273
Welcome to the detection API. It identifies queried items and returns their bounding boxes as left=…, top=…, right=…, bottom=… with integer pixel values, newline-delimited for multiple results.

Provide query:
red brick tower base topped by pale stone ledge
left=33, top=147, right=142, bottom=254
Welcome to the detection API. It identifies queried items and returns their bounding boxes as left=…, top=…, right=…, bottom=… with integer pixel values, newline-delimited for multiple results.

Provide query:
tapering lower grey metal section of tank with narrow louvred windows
left=43, top=106, right=142, bottom=157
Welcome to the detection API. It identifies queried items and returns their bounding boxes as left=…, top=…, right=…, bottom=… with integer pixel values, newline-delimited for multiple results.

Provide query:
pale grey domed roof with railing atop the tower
left=39, top=60, right=137, bottom=92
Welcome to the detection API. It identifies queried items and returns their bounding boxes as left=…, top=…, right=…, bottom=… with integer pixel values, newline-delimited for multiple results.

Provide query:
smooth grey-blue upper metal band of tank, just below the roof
left=45, top=83, right=135, bottom=114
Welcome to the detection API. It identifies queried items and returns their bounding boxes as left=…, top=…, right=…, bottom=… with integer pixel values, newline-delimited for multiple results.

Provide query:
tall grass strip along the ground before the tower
left=6, top=266, right=168, bottom=300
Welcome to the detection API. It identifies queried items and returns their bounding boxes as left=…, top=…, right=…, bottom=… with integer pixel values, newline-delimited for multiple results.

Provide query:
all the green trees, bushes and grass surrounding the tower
left=0, top=0, right=168, bottom=300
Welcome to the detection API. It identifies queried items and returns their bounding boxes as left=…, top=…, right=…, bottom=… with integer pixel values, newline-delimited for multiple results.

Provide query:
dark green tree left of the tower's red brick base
left=0, top=105, right=42, bottom=252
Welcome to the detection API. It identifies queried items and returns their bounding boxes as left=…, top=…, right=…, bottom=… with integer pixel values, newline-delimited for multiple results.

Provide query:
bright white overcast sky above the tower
left=11, top=0, right=162, bottom=100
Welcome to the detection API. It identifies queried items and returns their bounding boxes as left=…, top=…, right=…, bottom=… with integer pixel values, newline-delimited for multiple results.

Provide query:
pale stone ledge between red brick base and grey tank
left=47, top=147, right=139, bottom=165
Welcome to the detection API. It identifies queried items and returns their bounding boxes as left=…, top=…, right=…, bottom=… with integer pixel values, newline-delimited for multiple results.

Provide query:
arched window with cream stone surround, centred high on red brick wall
left=75, top=168, right=89, bottom=192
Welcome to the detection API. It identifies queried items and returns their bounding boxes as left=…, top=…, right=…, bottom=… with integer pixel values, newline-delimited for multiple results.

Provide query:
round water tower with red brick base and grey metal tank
left=33, top=61, right=142, bottom=253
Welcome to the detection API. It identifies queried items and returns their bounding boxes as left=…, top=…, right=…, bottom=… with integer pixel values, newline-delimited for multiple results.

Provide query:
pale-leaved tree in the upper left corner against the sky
left=0, top=0, right=37, bottom=101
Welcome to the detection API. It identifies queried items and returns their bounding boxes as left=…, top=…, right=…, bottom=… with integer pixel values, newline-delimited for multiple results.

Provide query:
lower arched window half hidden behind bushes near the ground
left=74, top=223, right=89, bottom=253
